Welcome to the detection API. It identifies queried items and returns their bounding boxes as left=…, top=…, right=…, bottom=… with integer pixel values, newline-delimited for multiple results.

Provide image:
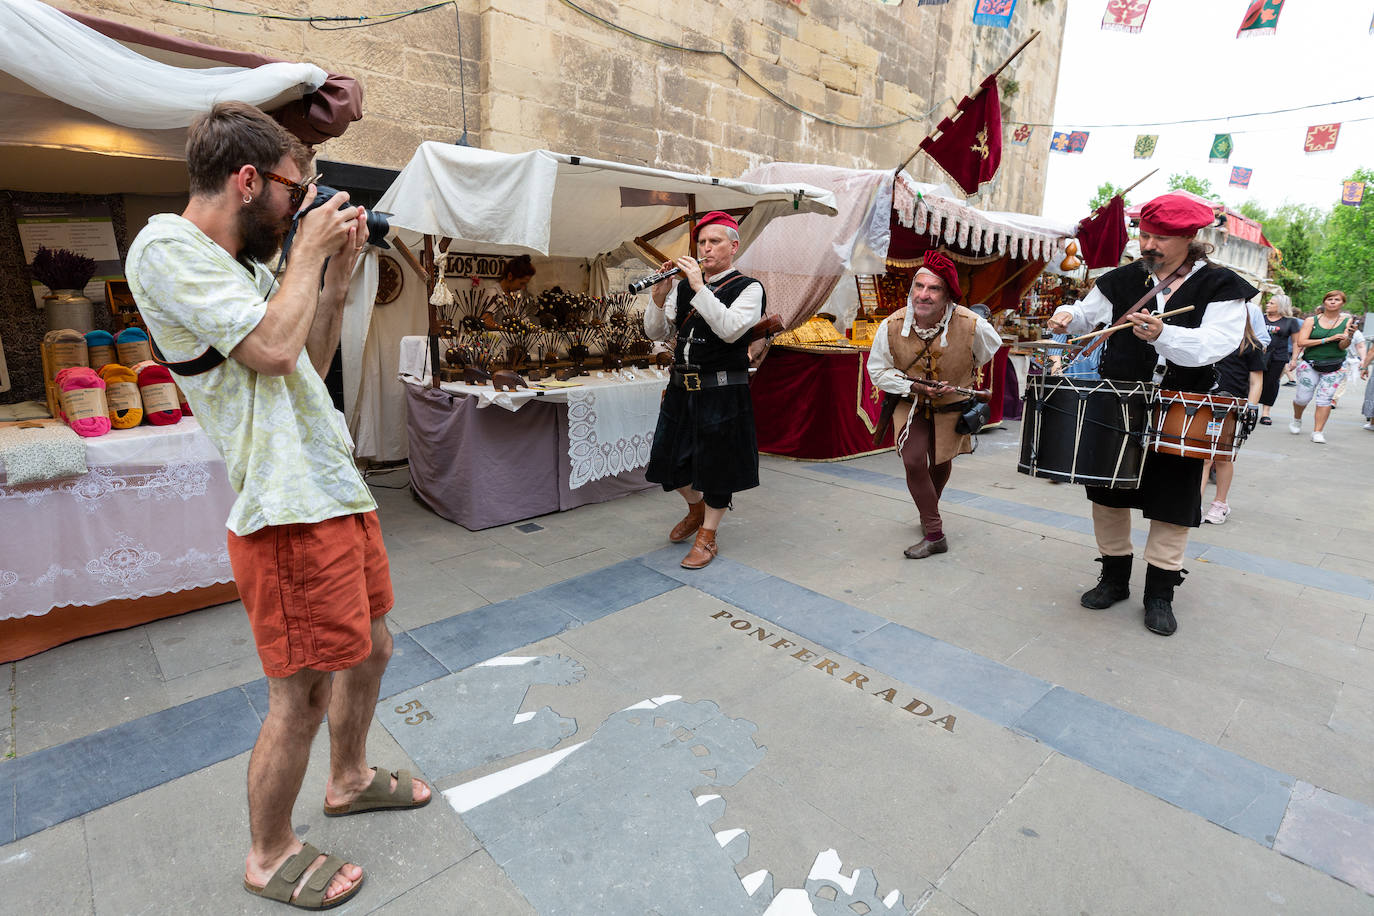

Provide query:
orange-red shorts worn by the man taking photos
left=229, top=511, right=396, bottom=677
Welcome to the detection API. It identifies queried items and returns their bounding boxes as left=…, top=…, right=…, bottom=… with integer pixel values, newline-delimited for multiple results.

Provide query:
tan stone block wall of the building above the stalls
left=50, top=0, right=1065, bottom=213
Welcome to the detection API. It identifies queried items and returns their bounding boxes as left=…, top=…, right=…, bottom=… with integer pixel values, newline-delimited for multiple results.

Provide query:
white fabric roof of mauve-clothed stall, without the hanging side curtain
left=376, top=141, right=835, bottom=261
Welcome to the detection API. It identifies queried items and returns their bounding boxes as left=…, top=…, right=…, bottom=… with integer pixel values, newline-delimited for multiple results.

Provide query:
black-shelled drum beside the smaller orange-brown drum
left=1017, top=375, right=1156, bottom=490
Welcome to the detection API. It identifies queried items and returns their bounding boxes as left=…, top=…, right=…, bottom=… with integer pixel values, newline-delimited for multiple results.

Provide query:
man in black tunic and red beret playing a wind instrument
left=644, top=211, right=767, bottom=569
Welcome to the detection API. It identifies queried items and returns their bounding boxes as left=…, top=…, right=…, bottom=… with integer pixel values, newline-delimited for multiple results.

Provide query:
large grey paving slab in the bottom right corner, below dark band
left=938, top=755, right=1371, bottom=916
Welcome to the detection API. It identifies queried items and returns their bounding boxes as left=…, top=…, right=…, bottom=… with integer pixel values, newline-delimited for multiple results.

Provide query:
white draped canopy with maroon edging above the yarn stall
left=0, top=0, right=360, bottom=194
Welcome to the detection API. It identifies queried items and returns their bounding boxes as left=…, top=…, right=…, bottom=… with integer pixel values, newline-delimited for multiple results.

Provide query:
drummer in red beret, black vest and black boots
left=1048, top=192, right=1259, bottom=636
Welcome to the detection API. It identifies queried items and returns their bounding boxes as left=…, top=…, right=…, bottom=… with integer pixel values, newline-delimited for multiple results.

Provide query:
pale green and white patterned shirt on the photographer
left=126, top=213, right=376, bottom=536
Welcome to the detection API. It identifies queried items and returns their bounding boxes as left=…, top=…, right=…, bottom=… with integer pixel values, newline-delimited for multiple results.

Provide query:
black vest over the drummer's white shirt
left=1096, top=261, right=1259, bottom=391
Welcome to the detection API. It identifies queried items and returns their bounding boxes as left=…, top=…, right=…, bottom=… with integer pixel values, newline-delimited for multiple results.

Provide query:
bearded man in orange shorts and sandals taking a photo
left=126, top=102, right=430, bottom=909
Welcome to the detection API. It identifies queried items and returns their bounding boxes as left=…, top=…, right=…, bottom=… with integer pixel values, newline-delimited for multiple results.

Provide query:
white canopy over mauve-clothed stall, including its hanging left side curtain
left=344, top=141, right=837, bottom=460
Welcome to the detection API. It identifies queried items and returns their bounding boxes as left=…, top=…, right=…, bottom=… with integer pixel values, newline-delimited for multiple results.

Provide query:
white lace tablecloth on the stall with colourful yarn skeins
left=0, top=417, right=234, bottom=619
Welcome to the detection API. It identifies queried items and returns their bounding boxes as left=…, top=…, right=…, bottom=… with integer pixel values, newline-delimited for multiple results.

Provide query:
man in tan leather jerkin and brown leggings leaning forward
left=868, top=251, right=1002, bottom=560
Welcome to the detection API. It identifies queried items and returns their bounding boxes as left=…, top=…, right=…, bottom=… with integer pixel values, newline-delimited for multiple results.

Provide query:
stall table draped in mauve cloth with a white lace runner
left=400, top=336, right=668, bottom=530
